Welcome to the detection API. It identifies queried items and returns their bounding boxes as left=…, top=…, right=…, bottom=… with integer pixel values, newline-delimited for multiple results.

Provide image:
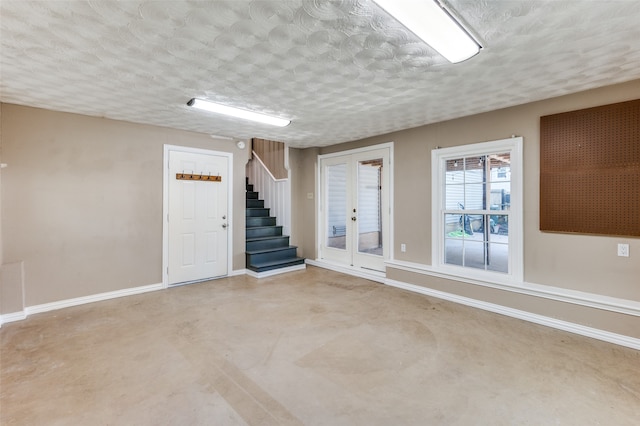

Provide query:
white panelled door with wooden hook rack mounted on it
left=167, top=150, right=229, bottom=285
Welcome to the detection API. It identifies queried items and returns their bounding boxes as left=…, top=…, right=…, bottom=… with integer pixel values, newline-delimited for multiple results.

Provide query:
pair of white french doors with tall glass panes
left=320, top=147, right=390, bottom=272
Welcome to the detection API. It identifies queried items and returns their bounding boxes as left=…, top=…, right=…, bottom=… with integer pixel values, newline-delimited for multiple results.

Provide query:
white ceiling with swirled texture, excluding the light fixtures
left=0, top=0, right=640, bottom=147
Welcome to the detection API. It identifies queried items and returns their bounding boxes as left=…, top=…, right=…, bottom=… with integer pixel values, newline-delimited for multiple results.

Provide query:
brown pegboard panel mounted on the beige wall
left=540, top=99, right=640, bottom=237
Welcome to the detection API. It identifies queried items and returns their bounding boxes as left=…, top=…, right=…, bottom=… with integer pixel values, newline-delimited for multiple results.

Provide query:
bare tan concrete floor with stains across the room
left=0, top=267, right=640, bottom=426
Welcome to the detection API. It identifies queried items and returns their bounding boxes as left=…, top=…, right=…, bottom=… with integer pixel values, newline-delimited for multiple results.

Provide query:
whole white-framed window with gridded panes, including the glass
left=431, top=137, right=523, bottom=283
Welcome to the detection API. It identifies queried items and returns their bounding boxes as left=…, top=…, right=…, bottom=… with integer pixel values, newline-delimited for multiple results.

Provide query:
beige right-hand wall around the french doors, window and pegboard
left=294, top=80, right=640, bottom=337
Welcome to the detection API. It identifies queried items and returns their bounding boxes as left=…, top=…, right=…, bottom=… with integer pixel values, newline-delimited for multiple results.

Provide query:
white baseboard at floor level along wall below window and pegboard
left=385, top=279, right=640, bottom=350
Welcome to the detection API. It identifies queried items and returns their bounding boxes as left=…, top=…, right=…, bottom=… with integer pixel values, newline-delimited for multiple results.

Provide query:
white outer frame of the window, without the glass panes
left=431, top=137, right=524, bottom=285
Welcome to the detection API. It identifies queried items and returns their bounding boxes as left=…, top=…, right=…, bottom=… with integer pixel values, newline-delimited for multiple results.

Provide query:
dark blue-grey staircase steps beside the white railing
left=245, top=179, right=304, bottom=273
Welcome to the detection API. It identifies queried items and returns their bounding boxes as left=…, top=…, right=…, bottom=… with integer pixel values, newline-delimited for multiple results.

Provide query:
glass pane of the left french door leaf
left=325, top=163, right=347, bottom=250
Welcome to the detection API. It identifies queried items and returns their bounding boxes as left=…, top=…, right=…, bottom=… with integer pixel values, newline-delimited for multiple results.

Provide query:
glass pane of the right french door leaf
left=354, top=158, right=383, bottom=256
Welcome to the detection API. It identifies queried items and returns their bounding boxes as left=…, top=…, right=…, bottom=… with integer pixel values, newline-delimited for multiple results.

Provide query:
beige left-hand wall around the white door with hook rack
left=0, top=104, right=248, bottom=313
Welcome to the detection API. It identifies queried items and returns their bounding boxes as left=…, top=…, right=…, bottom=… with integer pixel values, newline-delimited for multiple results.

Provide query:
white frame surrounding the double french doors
left=315, top=142, right=394, bottom=276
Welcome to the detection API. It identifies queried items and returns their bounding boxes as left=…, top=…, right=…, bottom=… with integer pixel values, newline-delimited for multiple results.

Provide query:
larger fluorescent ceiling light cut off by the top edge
left=373, top=0, right=482, bottom=64
